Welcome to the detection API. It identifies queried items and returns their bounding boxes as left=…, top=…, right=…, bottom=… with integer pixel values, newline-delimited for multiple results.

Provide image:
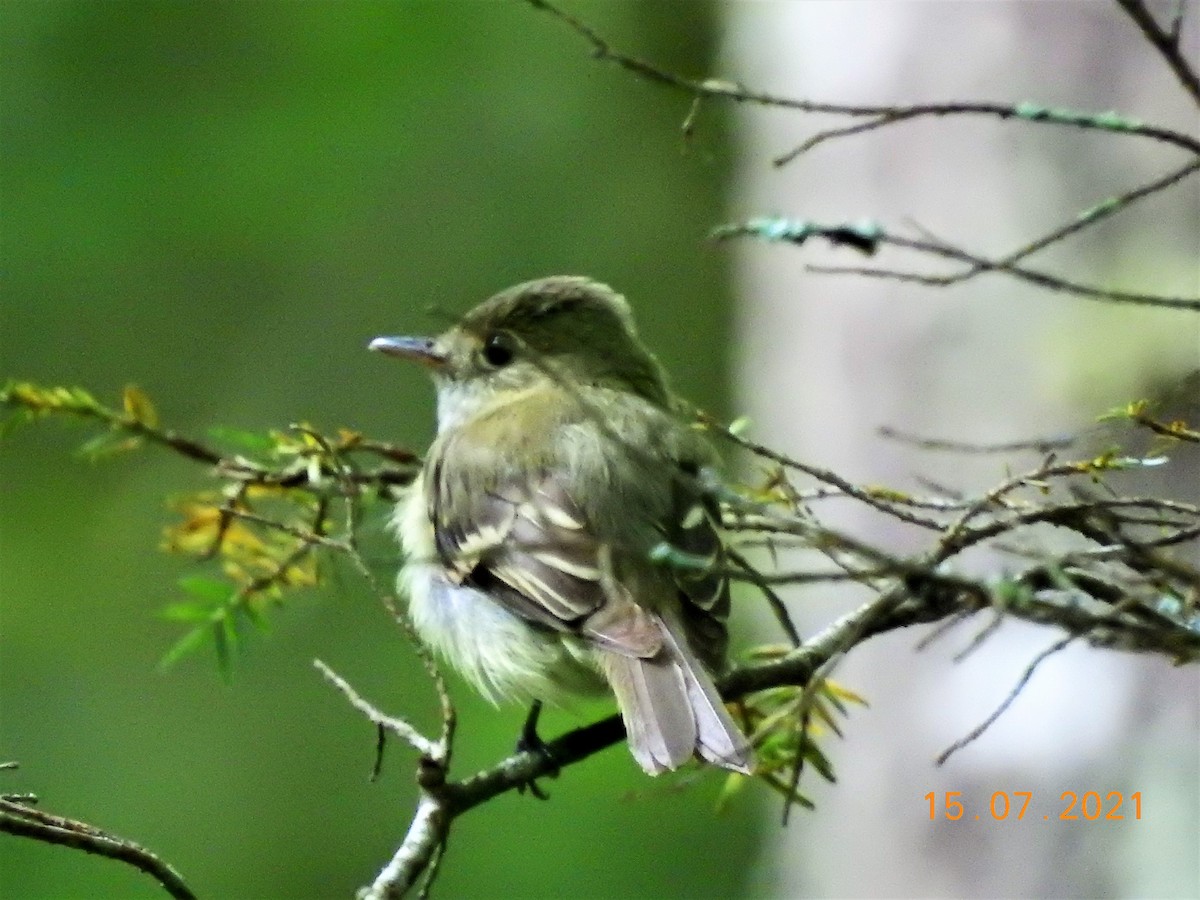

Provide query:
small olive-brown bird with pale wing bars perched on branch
left=370, top=276, right=752, bottom=775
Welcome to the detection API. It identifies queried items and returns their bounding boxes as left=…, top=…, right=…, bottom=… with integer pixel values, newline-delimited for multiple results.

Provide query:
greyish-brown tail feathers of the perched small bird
left=602, top=618, right=754, bottom=775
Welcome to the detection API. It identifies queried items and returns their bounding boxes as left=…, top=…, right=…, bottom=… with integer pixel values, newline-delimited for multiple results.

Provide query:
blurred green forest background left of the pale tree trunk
left=0, top=0, right=761, bottom=898
